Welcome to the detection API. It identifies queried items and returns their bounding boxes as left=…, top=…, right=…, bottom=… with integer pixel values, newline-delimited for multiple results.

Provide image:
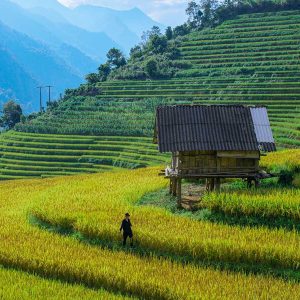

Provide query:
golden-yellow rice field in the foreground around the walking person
left=0, top=151, right=300, bottom=299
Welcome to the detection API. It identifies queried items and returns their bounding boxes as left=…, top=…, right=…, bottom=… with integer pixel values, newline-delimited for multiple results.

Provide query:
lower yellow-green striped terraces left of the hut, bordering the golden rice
left=0, top=131, right=166, bottom=180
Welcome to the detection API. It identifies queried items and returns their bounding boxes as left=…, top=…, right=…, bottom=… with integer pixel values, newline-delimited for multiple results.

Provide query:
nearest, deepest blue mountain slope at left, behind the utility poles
left=0, top=23, right=82, bottom=110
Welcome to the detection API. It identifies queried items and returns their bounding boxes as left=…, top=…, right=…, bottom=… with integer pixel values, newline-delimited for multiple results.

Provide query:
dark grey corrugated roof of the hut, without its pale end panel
left=156, top=105, right=276, bottom=152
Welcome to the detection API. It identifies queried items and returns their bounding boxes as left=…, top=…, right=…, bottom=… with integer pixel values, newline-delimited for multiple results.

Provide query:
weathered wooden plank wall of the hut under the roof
left=172, top=151, right=260, bottom=175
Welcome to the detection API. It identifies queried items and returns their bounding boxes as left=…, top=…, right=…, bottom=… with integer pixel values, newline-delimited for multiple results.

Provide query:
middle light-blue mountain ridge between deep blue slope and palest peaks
left=0, top=0, right=119, bottom=62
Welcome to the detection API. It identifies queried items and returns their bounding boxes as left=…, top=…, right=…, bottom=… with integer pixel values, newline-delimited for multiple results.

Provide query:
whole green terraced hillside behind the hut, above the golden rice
left=0, top=11, right=300, bottom=179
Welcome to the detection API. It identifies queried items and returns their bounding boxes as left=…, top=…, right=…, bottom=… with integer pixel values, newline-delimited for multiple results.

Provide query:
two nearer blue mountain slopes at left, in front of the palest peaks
left=0, top=0, right=113, bottom=112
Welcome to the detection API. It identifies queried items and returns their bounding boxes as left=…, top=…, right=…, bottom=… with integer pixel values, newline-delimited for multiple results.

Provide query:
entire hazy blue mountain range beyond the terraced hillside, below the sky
left=0, top=0, right=162, bottom=112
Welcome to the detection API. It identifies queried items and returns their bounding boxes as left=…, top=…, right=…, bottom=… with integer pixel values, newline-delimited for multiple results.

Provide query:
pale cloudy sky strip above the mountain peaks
left=59, top=0, right=190, bottom=26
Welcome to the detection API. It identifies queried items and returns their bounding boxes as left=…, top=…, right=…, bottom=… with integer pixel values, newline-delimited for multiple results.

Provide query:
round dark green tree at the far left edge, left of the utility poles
left=0, top=100, right=23, bottom=129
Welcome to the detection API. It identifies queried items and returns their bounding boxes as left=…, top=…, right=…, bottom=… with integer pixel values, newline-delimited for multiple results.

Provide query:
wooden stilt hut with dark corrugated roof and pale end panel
left=154, top=105, right=276, bottom=201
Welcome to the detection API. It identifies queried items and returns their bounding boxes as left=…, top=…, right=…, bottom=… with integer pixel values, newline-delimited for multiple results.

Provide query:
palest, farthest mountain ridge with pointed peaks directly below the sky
left=9, top=0, right=164, bottom=53
